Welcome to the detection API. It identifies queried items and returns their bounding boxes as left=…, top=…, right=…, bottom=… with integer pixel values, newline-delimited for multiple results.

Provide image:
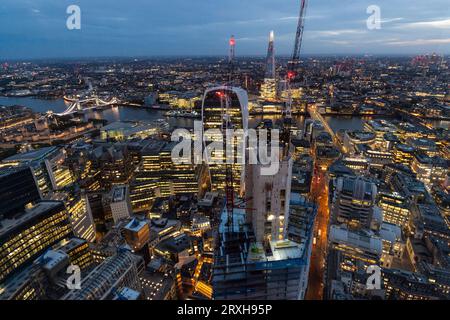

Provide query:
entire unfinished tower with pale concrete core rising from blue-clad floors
left=212, top=117, right=315, bottom=300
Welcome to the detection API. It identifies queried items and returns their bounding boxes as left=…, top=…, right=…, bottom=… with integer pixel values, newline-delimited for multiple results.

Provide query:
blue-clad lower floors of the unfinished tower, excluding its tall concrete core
left=212, top=209, right=312, bottom=300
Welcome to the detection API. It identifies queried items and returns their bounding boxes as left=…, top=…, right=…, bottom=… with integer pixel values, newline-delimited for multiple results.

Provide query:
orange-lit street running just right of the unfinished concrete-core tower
left=305, top=164, right=330, bottom=300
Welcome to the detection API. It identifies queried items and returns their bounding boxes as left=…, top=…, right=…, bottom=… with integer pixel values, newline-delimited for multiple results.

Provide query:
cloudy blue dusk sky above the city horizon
left=0, top=0, right=450, bottom=59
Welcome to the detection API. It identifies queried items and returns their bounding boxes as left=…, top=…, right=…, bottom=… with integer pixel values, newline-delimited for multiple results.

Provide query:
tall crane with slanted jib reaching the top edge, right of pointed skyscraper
left=285, top=0, right=308, bottom=119
